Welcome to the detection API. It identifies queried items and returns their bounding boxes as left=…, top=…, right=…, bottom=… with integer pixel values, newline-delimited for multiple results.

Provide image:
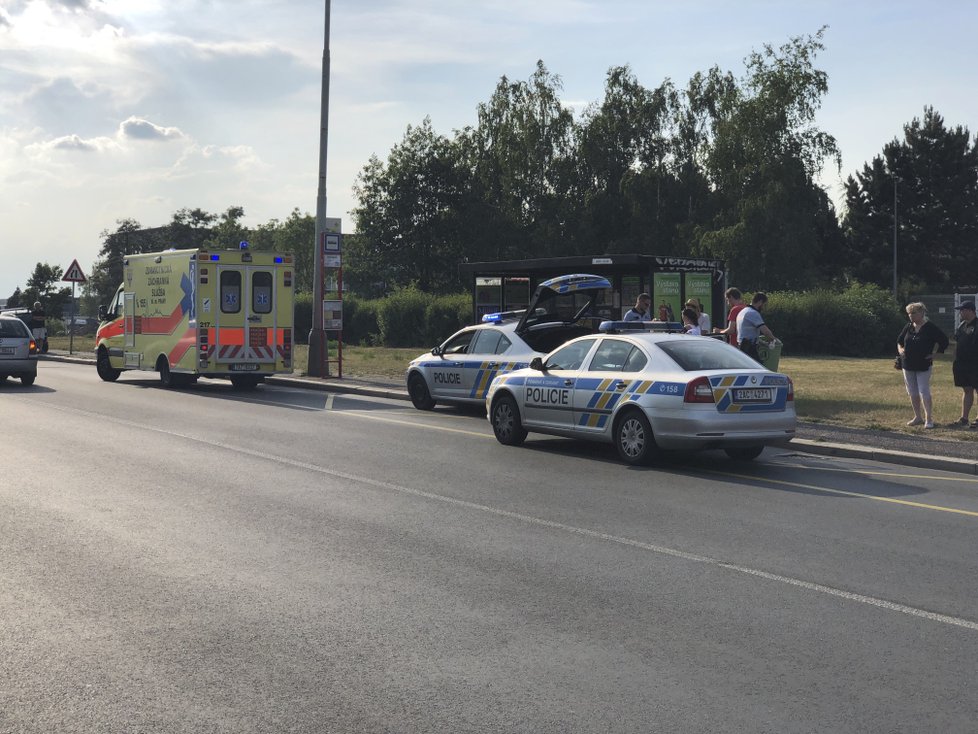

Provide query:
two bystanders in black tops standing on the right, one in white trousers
left=895, top=301, right=978, bottom=429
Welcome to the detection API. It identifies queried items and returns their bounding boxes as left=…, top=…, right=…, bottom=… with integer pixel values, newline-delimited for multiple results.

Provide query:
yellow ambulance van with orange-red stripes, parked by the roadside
left=95, top=243, right=295, bottom=389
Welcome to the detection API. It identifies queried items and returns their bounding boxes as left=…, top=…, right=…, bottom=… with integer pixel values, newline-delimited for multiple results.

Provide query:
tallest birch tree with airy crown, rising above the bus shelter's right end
left=692, top=28, right=840, bottom=289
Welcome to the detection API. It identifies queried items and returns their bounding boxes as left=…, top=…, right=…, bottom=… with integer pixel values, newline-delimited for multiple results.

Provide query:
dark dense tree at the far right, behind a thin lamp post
left=843, top=107, right=978, bottom=290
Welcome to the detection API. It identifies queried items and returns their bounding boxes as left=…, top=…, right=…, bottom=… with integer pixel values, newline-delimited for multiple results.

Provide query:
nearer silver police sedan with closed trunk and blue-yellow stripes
left=486, top=322, right=795, bottom=464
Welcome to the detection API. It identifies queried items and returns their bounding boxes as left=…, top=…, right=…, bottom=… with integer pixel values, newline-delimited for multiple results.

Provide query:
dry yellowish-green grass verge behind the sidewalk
left=50, top=336, right=978, bottom=442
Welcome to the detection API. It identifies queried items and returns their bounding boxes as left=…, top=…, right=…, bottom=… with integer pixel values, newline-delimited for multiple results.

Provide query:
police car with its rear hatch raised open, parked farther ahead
left=407, top=274, right=611, bottom=410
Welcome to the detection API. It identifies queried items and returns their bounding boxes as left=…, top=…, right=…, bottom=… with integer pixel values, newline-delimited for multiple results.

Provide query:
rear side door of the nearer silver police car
left=573, top=337, right=648, bottom=433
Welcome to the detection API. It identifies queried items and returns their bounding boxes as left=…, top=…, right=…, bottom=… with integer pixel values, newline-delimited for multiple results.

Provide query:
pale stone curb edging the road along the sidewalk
left=43, top=354, right=978, bottom=476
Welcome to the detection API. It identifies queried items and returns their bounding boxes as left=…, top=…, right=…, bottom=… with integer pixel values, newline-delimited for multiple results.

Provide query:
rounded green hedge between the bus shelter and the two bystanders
left=764, top=283, right=904, bottom=357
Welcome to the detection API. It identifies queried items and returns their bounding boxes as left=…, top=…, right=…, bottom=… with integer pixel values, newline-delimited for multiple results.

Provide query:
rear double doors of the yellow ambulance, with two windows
left=211, top=263, right=277, bottom=372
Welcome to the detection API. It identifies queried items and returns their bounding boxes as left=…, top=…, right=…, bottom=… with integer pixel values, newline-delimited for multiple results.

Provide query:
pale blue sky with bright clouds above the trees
left=0, top=0, right=978, bottom=298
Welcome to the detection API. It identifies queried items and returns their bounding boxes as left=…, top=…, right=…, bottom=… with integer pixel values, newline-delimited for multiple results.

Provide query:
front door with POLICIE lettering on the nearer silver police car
left=523, top=337, right=598, bottom=430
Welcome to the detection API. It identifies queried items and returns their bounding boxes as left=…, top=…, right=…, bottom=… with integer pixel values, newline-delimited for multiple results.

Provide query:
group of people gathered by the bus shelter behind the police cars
left=622, top=288, right=776, bottom=362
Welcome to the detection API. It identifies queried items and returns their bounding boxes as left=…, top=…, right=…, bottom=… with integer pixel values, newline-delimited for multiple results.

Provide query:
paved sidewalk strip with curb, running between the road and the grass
left=42, top=351, right=978, bottom=475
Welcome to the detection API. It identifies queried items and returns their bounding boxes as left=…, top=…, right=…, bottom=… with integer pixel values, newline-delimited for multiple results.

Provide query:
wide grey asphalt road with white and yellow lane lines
left=0, top=362, right=978, bottom=733
